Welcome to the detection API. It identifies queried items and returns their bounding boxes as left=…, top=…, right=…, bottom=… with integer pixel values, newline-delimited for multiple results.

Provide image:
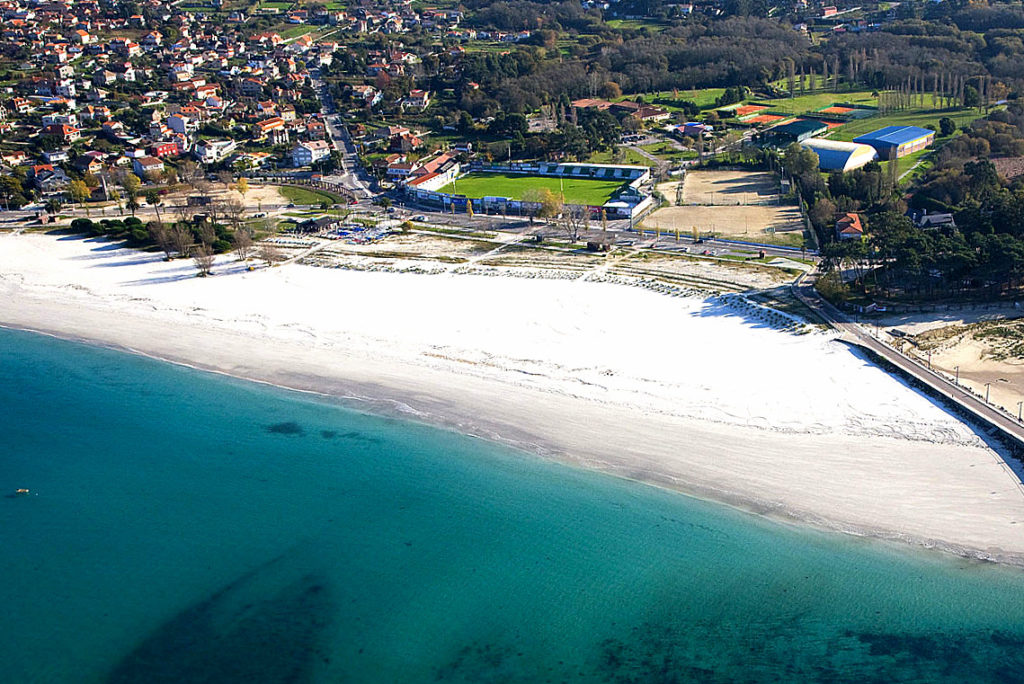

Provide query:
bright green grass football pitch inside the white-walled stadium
left=440, top=173, right=623, bottom=206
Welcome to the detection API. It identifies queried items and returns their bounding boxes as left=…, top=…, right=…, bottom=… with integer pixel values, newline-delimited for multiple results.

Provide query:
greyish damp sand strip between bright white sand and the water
left=0, top=235, right=1024, bottom=566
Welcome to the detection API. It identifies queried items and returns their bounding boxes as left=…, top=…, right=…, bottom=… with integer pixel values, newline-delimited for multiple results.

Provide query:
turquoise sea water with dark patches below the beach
left=0, top=330, right=1024, bottom=683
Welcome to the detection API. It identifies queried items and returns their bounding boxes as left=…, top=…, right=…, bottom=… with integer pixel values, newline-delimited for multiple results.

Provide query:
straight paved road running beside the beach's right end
left=793, top=274, right=1024, bottom=444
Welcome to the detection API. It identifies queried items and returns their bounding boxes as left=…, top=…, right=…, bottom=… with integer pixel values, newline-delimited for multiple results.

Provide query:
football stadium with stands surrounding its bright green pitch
left=403, top=162, right=654, bottom=218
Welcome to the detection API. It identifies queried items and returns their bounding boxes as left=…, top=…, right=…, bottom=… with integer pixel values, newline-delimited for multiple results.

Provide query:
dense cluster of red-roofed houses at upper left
left=0, top=0, right=530, bottom=205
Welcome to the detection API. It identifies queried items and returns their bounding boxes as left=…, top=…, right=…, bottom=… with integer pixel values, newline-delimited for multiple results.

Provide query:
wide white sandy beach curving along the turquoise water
left=6, top=234, right=1024, bottom=564
